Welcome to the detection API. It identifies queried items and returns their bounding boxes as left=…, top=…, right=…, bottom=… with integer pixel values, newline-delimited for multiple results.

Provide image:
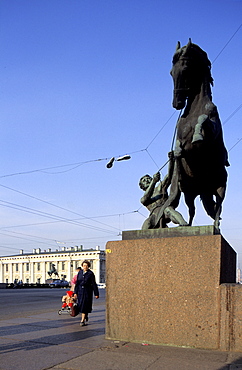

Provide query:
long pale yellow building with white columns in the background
left=0, top=246, right=105, bottom=284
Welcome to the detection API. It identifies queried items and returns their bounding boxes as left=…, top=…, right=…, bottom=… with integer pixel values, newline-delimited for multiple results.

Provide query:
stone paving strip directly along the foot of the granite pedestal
left=48, top=340, right=242, bottom=370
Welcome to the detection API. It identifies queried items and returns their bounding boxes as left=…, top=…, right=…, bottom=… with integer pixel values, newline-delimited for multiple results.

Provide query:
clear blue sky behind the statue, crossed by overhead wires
left=0, top=0, right=242, bottom=264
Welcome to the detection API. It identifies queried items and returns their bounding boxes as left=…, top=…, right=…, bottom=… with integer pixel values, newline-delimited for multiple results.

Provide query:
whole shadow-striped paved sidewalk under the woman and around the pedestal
left=0, top=302, right=242, bottom=370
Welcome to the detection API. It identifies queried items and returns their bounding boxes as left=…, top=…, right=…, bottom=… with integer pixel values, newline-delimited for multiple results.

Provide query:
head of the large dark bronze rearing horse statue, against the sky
left=170, top=39, right=213, bottom=110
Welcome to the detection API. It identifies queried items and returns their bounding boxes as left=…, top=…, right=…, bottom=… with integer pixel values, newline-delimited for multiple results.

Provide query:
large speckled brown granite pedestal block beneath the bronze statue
left=106, top=227, right=237, bottom=350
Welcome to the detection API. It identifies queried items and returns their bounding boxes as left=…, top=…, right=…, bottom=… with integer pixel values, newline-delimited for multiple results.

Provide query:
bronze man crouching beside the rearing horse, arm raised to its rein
left=139, top=152, right=188, bottom=230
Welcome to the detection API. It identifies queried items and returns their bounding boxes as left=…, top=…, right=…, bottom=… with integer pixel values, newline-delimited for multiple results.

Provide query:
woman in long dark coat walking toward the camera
left=74, top=260, right=99, bottom=326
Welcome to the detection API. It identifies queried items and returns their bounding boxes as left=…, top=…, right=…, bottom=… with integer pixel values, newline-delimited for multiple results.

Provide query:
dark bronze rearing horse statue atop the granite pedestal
left=157, top=40, right=229, bottom=229
